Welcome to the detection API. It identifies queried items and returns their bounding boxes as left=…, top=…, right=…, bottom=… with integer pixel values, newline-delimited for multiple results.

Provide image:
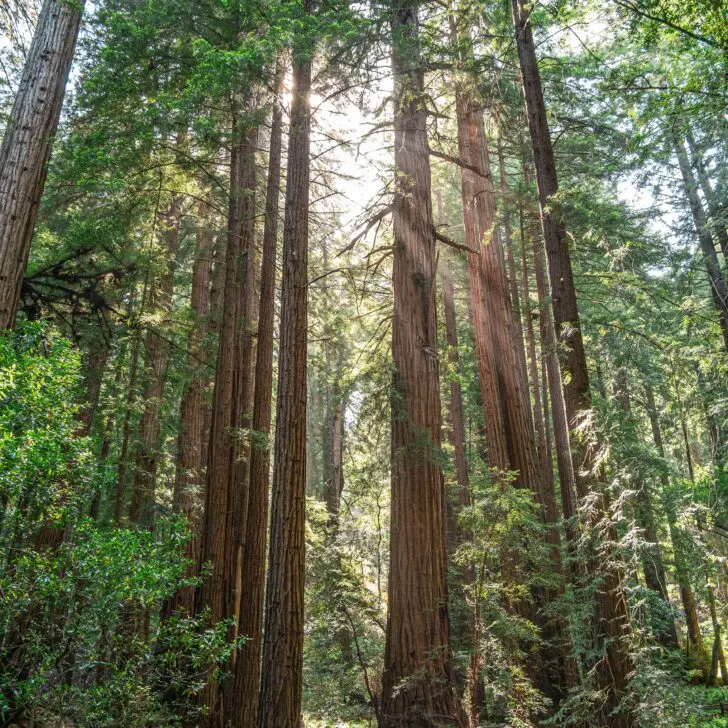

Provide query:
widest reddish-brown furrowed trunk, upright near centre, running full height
left=379, top=0, right=460, bottom=728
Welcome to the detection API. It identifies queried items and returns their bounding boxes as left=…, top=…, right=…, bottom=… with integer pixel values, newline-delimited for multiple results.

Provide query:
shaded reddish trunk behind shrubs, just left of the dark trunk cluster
left=167, top=202, right=213, bottom=616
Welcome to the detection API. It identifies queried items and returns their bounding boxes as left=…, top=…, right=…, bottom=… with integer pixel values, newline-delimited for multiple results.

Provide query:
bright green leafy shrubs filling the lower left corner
left=0, top=324, right=232, bottom=728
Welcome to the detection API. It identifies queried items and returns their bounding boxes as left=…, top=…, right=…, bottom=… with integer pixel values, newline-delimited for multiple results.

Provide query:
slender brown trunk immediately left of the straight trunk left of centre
left=230, top=59, right=285, bottom=728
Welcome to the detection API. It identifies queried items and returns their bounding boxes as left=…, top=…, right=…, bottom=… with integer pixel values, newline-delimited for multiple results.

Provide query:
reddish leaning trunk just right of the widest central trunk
left=455, top=31, right=562, bottom=700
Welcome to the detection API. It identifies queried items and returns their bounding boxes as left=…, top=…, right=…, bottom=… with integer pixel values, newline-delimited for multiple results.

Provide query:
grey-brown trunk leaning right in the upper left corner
left=0, top=0, right=84, bottom=329
